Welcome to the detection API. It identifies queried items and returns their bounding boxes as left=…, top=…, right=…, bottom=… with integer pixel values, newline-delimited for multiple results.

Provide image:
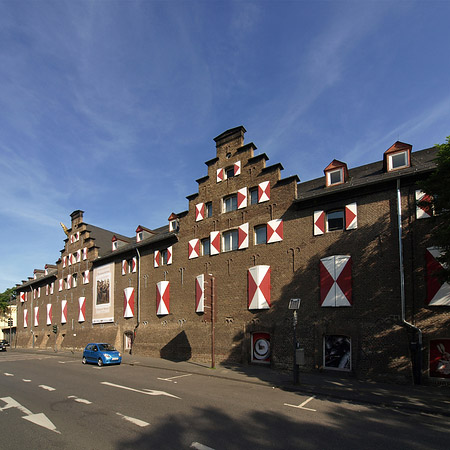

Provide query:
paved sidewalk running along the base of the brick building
left=8, top=349, right=450, bottom=417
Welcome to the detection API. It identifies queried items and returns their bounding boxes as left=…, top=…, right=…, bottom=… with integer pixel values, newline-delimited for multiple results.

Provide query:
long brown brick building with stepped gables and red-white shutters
left=17, top=127, right=450, bottom=382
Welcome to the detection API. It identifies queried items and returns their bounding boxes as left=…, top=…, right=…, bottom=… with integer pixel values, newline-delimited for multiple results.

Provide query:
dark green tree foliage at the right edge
left=420, top=136, right=450, bottom=281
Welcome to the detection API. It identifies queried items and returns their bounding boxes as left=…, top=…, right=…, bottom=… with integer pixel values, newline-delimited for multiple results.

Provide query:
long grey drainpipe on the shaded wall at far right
left=397, top=178, right=422, bottom=384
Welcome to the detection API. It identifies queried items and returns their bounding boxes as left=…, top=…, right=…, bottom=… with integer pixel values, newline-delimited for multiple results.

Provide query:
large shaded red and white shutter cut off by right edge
left=425, top=247, right=450, bottom=306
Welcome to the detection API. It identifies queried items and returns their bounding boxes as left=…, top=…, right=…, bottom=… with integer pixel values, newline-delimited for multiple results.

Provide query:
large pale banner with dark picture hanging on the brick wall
left=92, top=263, right=114, bottom=323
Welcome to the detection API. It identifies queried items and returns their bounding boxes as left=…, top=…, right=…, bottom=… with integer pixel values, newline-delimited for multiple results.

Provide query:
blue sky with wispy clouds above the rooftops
left=0, top=0, right=450, bottom=292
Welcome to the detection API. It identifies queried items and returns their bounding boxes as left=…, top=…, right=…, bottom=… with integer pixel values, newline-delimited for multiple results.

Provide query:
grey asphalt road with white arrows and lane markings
left=0, top=352, right=450, bottom=450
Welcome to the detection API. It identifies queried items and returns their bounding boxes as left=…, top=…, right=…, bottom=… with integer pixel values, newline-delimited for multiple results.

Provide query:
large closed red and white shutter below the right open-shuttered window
left=320, top=255, right=352, bottom=306
